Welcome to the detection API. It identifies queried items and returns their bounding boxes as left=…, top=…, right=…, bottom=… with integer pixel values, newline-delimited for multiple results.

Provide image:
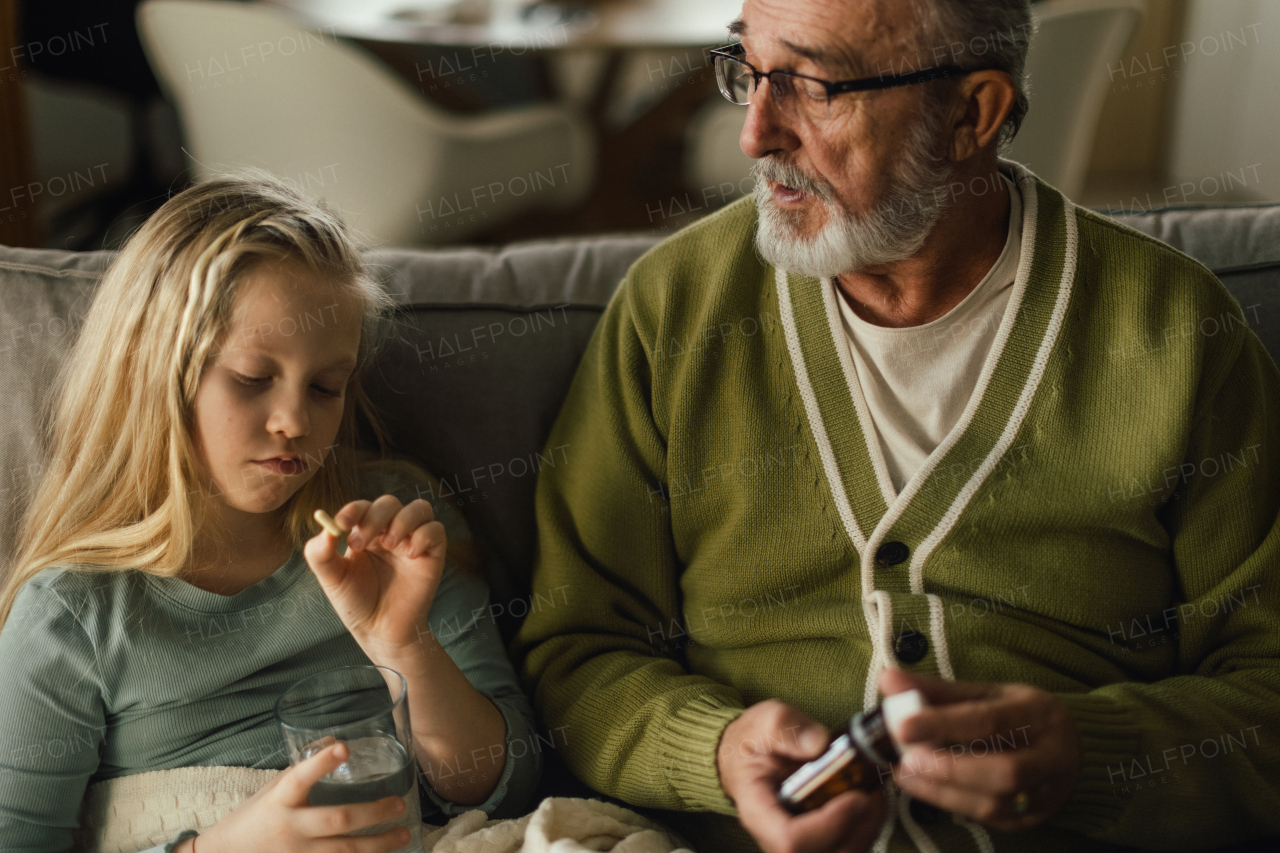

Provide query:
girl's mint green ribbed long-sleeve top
left=0, top=474, right=541, bottom=853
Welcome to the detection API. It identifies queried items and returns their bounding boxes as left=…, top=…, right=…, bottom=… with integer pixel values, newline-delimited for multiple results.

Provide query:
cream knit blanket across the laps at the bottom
left=72, top=767, right=692, bottom=853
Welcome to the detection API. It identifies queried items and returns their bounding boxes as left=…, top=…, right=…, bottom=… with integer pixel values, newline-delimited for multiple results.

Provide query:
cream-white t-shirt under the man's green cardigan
left=831, top=174, right=1023, bottom=492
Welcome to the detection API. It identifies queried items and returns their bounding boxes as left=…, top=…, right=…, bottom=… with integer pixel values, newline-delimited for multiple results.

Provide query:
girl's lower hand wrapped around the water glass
left=186, top=743, right=410, bottom=853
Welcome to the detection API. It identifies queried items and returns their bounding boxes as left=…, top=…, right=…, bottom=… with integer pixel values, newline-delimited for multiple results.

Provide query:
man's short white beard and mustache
left=751, top=105, right=955, bottom=279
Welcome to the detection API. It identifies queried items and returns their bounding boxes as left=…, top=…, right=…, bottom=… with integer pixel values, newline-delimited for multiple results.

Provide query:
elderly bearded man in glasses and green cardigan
left=516, top=0, right=1280, bottom=853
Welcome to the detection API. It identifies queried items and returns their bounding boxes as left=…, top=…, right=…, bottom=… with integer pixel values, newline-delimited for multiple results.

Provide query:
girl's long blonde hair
left=0, top=173, right=412, bottom=626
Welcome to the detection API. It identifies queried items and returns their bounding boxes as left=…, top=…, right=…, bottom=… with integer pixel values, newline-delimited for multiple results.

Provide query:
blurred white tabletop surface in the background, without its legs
left=264, top=0, right=742, bottom=50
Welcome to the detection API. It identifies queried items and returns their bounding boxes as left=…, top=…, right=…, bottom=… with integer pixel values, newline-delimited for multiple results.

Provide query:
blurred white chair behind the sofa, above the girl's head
left=138, top=0, right=596, bottom=246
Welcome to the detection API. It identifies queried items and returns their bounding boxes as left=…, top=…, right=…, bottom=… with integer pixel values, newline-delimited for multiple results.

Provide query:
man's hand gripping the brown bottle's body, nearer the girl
left=716, top=699, right=884, bottom=853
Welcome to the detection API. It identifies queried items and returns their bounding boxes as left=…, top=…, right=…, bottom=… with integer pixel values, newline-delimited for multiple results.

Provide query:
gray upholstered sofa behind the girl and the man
left=0, top=205, right=1280, bottom=793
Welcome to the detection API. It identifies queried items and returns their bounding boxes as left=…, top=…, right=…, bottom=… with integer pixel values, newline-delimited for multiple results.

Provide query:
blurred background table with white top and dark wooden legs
left=257, top=0, right=742, bottom=245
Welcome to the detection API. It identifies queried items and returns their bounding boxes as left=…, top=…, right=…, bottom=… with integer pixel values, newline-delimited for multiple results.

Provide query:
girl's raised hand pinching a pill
left=302, top=494, right=445, bottom=650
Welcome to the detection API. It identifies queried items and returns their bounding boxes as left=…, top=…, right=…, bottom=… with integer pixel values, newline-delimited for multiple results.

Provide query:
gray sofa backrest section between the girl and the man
left=367, top=237, right=657, bottom=604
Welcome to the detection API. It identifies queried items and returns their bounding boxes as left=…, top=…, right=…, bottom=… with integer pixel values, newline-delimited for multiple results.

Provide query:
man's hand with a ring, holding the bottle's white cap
left=878, top=670, right=1080, bottom=833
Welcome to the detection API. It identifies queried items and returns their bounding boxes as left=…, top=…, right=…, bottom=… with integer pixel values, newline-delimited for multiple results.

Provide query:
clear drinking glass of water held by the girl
left=275, top=665, right=422, bottom=853
